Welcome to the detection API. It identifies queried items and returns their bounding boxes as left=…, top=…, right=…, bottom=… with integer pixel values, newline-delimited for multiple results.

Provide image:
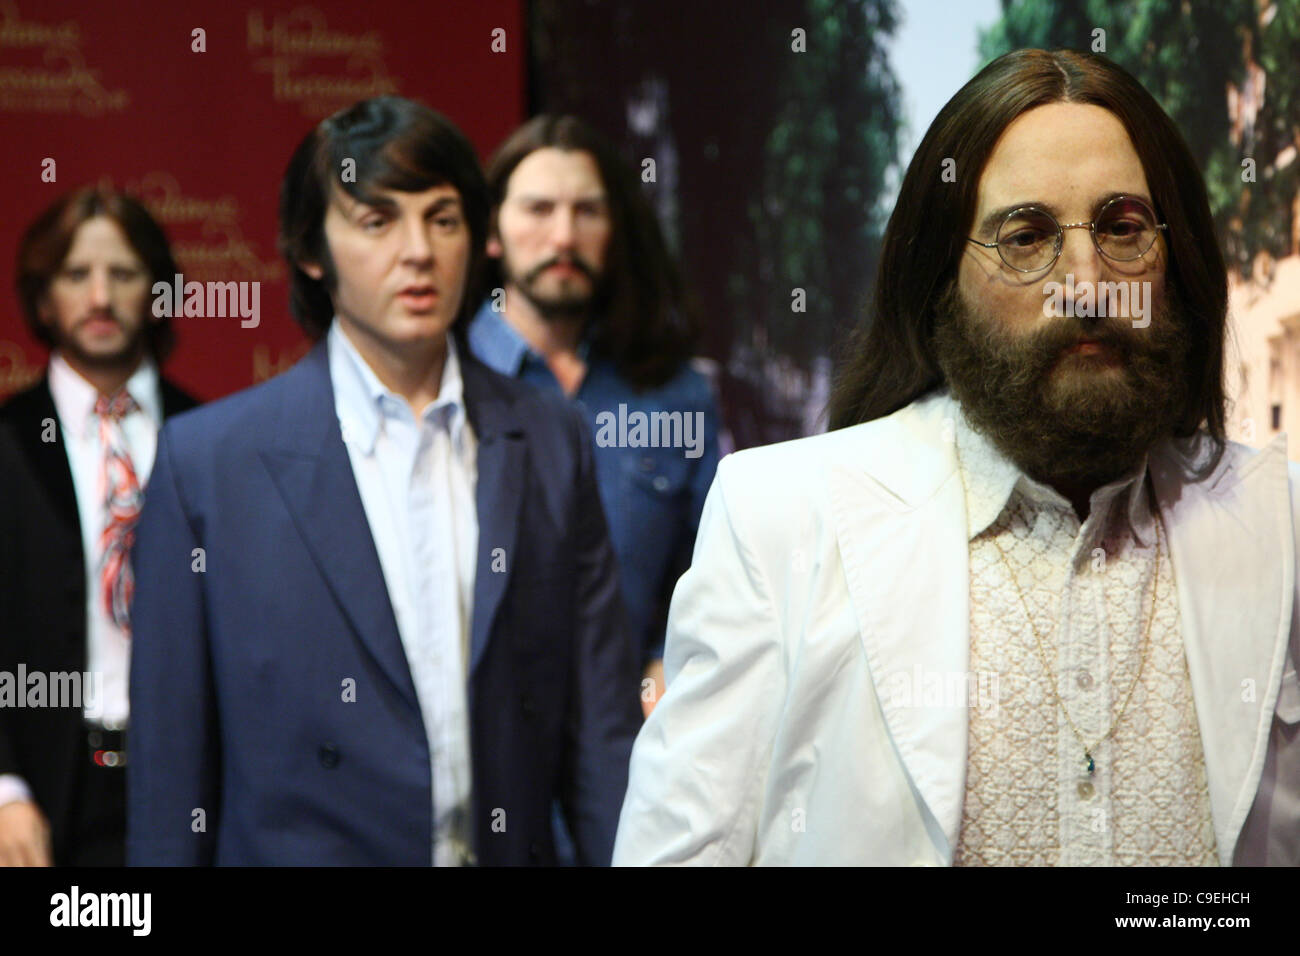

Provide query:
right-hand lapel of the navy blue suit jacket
left=458, top=347, right=528, bottom=678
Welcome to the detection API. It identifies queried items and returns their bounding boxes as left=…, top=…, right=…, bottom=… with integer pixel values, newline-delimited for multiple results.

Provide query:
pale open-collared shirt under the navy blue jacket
left=328, top=320, right=478, bottom=866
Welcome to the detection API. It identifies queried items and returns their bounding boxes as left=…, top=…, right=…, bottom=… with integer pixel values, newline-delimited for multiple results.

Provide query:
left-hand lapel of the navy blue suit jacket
left=261, top=342, right=419, bottom=710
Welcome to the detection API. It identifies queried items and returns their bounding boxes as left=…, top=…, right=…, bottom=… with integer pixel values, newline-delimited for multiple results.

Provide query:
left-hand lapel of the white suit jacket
left=828, top=395, right=970, bottom=860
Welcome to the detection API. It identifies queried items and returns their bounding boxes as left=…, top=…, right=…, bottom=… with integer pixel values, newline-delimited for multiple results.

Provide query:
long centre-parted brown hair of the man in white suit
left=831, top=49, right=1227, bottom=467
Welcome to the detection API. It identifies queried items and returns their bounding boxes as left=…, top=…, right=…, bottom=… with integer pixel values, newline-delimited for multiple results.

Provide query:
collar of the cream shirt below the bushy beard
left=953, top=401, right=1156, bottom=548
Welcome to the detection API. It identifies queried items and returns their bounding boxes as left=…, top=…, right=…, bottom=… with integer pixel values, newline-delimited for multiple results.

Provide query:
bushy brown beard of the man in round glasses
left=935, top=280, right=1188, bottom=486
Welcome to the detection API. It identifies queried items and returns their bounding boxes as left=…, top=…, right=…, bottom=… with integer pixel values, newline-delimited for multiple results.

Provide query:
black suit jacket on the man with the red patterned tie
left=0, top=378, right=195, bottom=865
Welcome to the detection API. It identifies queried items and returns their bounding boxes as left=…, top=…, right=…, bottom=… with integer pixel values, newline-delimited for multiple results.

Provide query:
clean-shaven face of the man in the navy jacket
left=303, top=185, right=471, bottom=355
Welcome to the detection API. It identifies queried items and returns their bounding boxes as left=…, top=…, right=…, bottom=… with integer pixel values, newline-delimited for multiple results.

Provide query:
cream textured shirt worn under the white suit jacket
left=954, top=403, right=1218, bottom=866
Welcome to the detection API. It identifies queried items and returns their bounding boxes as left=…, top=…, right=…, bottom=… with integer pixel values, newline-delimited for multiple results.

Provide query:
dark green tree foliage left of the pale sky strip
left=729, top=0, right=902, bottom=362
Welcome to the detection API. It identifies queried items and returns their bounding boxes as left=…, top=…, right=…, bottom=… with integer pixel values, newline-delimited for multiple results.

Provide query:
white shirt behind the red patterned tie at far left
left=0, top=351, right=163, bottom=806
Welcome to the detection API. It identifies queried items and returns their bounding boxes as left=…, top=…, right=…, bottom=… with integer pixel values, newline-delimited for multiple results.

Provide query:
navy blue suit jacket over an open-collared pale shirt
left=127, top=342, right=641, bottom=865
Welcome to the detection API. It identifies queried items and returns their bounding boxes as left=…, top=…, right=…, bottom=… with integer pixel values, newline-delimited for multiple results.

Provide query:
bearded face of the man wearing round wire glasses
left=936, top=103, right=1187, bottom=480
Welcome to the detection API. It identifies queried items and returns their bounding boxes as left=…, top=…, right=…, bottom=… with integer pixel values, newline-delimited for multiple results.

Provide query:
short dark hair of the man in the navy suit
left=280, top=96, right=488, bottom=339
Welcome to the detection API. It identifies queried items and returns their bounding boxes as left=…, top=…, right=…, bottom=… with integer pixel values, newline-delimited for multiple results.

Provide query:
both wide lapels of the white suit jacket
left=829, top=394, right=1296, bottom=865
